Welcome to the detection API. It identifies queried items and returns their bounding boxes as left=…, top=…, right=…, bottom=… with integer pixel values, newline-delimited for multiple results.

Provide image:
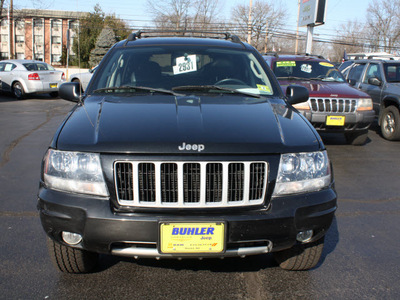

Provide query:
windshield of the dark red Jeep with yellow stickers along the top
left=273, top=60, right=346, bottom=82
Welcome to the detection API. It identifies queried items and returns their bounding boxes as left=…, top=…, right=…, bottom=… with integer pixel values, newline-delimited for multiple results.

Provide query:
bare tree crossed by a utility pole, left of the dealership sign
left=232, top=0, right=287, bottom=50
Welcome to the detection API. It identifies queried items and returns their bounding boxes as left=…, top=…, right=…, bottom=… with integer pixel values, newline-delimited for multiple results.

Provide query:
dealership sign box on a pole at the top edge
left=298, top=0, right=328, bottom=27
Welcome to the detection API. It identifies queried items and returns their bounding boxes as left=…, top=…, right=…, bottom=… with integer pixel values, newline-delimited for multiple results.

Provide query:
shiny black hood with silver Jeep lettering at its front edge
left=52, top=95, right=323, bottom=154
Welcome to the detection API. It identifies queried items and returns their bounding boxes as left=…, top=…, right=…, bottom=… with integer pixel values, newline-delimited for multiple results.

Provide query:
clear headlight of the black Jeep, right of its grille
left=274, top=151, right=331, bottom=196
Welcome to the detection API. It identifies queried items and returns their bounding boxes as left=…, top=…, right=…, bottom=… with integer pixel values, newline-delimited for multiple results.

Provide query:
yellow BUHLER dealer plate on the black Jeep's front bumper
left=160, top=223, right=225, bottom=253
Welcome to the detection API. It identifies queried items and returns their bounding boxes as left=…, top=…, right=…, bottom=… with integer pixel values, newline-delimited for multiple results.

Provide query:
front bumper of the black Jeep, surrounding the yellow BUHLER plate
left=38, top=187, right=336, bottom=258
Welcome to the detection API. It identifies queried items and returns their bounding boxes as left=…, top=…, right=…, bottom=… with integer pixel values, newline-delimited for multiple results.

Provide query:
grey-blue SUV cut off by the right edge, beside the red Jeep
left=344, top=59, right=400, bottom=141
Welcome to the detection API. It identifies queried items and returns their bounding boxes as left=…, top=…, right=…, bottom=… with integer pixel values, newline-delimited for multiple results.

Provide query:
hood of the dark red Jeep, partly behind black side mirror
left=278, top=79, right=370, bottom=98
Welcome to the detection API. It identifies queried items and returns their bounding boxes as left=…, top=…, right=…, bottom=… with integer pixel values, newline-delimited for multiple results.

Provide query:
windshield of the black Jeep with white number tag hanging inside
left=88, top=45, right=278, bottom=96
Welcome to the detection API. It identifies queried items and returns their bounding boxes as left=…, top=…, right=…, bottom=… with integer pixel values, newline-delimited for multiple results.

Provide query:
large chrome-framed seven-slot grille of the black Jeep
left=114, top=161, right=268, bottom=208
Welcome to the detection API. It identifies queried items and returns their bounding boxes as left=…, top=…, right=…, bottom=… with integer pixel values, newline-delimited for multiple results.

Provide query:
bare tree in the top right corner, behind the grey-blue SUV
left=367, top=0, right=400, bottom=52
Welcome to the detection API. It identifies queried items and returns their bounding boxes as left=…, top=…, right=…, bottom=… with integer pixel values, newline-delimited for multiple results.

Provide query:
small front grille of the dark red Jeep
left=309, top=98, right=357, bottom=113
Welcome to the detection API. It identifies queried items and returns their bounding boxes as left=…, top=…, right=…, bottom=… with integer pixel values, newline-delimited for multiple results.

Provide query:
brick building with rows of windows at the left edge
left=0, top=9, right=88, bottom=65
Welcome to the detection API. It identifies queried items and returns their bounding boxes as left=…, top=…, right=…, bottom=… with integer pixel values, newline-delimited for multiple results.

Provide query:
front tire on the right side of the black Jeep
left=274, top=237, right=325, bottom=271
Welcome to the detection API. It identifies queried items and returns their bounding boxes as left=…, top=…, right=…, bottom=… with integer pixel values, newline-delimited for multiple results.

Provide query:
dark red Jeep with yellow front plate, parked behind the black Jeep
left=263, top=53, right=374, bottom=145
